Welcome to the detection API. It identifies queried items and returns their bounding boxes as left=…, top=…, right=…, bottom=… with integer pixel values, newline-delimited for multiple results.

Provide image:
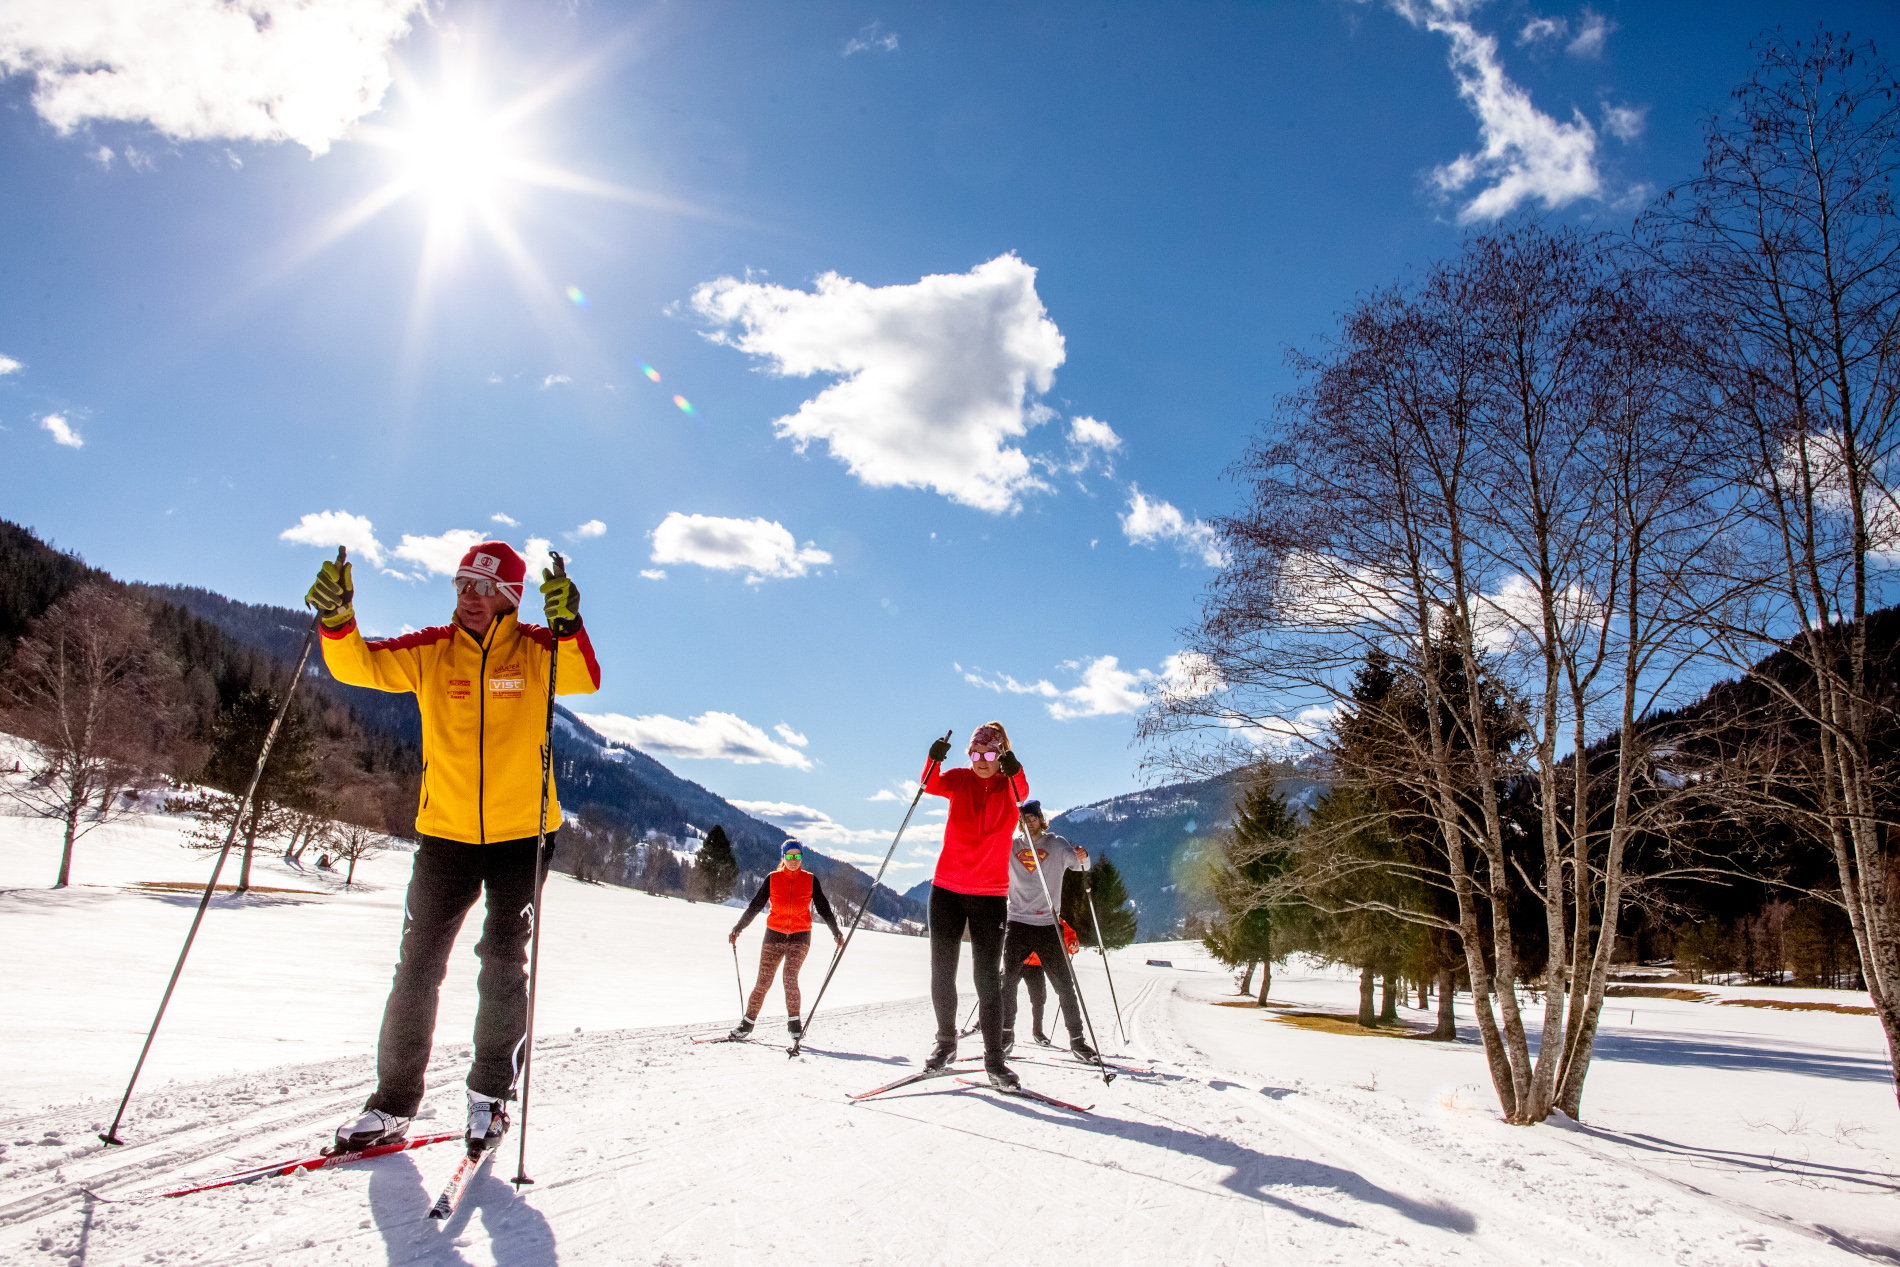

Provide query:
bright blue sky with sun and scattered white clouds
left=0, top=0, right=1900, bottom=883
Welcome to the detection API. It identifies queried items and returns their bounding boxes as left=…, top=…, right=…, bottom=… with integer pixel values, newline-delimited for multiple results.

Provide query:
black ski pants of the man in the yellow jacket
left=365, top=832, right=555, bottom=1117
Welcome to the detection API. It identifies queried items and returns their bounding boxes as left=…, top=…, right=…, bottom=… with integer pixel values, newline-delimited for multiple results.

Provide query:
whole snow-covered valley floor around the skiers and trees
left=0, top=815, right=1900, bottom=1267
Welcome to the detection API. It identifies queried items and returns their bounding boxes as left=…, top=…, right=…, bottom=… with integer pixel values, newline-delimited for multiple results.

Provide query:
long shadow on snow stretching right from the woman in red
left=934, top=1092, right=1478, bottom=1235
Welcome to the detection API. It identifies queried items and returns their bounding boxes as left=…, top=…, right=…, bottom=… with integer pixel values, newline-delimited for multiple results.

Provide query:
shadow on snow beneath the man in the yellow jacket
left=369, top=1153, right=561, bottom=1267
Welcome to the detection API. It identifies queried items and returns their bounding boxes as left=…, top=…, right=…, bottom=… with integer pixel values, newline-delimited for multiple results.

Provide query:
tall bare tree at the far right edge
left=1647, top=30, right=1900, bottom=1092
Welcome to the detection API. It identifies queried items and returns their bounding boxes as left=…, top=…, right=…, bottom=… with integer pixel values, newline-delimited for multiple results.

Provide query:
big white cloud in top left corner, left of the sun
left=0, top=0, right=424, bottom=161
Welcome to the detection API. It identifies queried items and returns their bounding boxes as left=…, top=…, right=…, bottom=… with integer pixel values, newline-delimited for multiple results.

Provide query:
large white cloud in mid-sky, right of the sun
left=692, top=255, right=1066, bottom=513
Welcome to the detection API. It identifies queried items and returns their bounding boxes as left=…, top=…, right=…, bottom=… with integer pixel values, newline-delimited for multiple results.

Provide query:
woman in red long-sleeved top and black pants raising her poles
left=923, top=722, right=1030, bottom=1088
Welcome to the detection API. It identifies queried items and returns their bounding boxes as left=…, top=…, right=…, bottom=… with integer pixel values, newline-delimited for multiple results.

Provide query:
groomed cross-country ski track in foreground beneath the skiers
left=0, top=973, right=1868, bottom=1267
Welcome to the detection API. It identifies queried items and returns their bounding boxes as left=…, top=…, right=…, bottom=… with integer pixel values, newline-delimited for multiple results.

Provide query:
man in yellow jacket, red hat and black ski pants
left=308, top=541, right=600, bottom=1151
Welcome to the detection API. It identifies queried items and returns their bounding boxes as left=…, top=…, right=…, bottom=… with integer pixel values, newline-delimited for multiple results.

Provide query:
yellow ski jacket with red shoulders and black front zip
left=323, top=612, right=600, bottom=845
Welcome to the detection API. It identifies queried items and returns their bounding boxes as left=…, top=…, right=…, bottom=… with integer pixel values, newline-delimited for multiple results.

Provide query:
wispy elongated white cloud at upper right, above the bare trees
left=1393, top=0, right=1602, bottom=224
